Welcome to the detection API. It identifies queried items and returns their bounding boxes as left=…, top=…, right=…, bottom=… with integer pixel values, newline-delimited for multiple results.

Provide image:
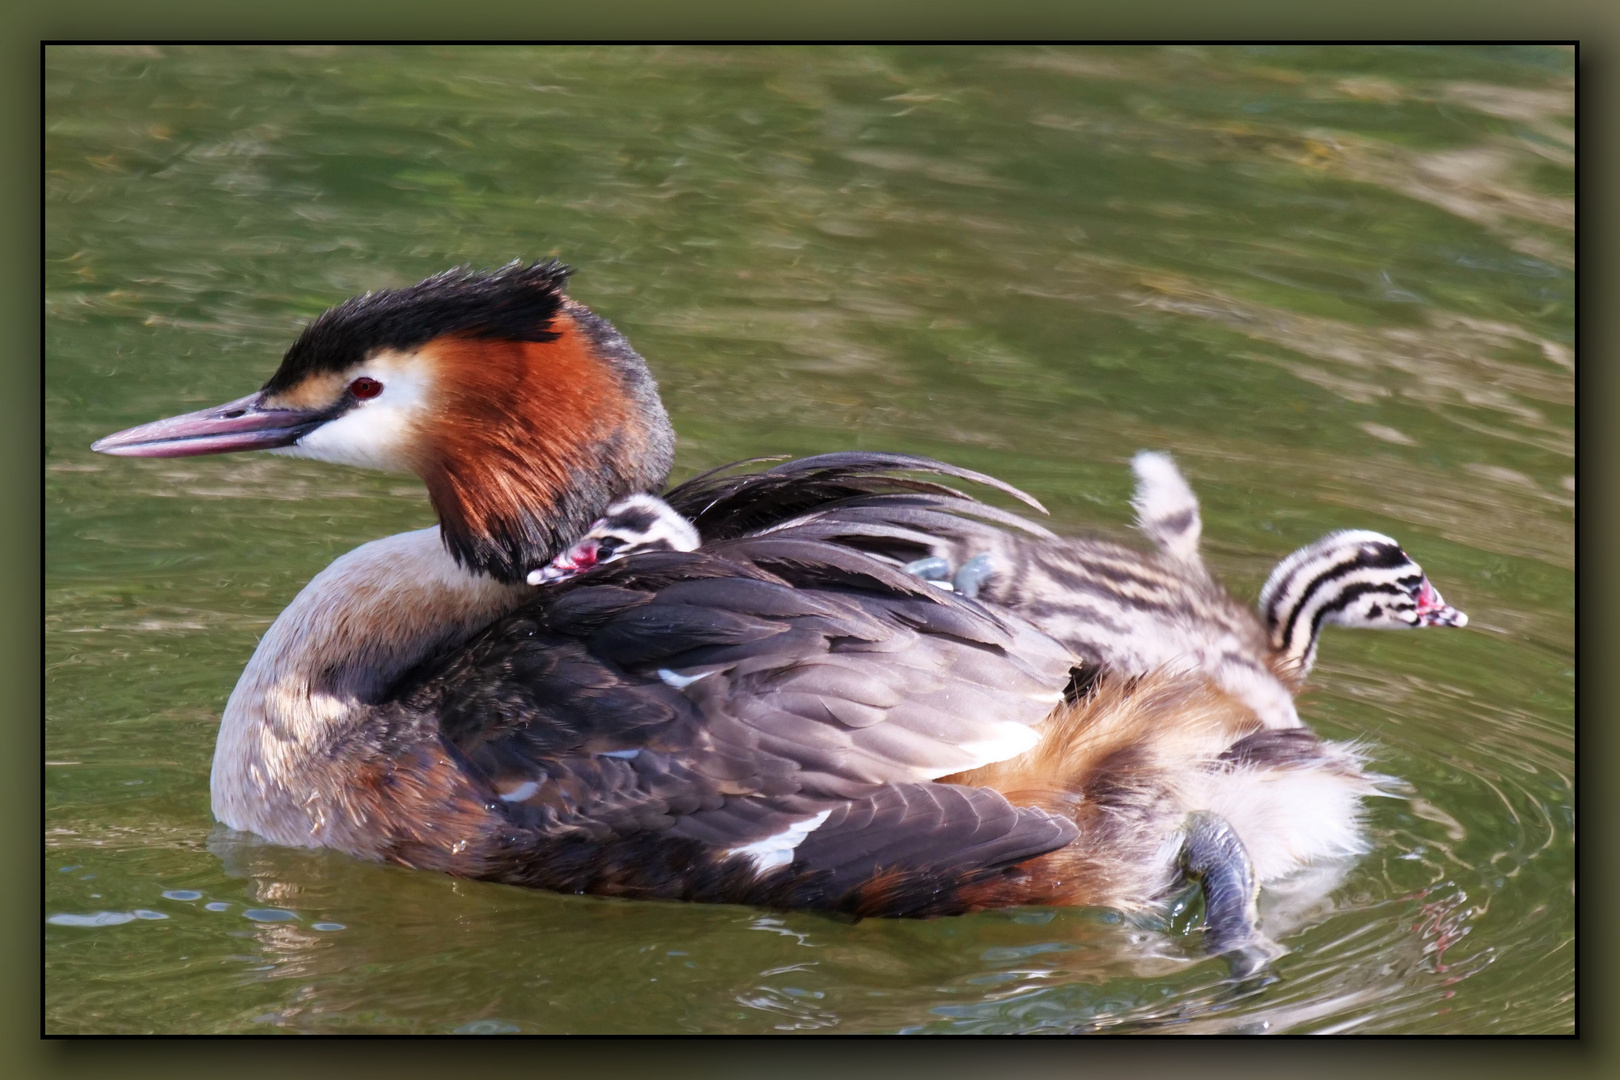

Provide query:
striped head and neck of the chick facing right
left=1260, top=529, right=1468, bottom=675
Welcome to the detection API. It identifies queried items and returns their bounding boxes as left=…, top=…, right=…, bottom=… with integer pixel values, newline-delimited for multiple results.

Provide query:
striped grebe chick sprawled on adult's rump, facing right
left=881, top=450, right=1468, bottom=729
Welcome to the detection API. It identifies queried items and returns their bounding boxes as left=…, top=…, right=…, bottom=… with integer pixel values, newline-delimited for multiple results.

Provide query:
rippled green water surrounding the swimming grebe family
left=41, top=47, right=1575, bottom=1033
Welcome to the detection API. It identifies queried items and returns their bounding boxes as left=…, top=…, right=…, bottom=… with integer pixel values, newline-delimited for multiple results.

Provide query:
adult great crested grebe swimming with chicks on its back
left=94, top=262, right=1470, bottom=949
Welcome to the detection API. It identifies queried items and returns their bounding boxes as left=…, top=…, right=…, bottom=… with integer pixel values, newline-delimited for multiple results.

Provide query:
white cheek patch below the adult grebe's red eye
left=271, top=353, right=433, bottom=473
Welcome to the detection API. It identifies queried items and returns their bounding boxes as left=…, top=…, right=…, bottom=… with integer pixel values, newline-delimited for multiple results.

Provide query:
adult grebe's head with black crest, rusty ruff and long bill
left=92, top=262, right=674, bottom=581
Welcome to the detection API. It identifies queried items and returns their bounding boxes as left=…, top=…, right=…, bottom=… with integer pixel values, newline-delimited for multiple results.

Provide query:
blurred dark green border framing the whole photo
left=15, top=0, right=1620, bottom=1080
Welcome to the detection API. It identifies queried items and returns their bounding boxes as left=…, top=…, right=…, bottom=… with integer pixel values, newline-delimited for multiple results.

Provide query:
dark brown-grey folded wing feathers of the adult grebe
left=389, top=453, right=1074, bottom=913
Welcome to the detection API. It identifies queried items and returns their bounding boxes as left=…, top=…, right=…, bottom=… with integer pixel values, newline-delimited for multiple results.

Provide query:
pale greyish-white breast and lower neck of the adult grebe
left=211, top=528, right=533, bottom=855
